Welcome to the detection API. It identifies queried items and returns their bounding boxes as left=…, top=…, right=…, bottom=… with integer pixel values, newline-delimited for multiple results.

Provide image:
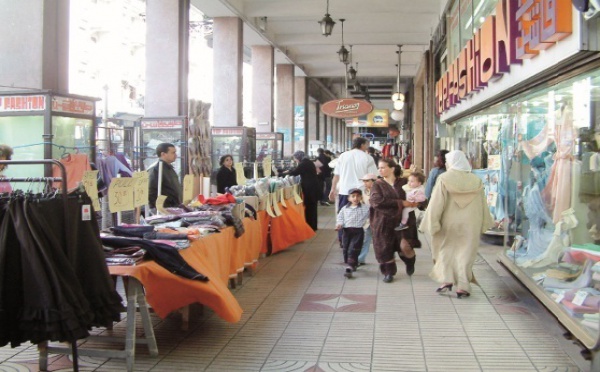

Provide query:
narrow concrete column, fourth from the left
left=251, top=45, right=275, bottom=133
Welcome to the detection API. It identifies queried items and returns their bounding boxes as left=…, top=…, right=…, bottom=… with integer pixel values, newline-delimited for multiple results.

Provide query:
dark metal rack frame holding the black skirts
left=0, top=159, right=79, bottom=372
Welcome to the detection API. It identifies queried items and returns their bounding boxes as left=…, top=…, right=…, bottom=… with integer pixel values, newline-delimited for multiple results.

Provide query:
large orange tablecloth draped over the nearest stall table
left=109, top=218, right=261, bottom=323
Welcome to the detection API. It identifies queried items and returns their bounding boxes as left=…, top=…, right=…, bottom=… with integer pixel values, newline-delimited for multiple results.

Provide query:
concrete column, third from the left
left=213, top=17, right=244, bottom=127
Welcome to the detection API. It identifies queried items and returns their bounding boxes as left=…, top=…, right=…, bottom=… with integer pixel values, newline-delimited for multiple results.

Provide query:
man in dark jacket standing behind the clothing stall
left=148, top=143, right=183, bottom=208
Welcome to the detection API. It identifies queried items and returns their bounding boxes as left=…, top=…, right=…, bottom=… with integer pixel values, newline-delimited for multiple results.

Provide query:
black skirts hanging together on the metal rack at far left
left=0, top=194, right=121, bottom=347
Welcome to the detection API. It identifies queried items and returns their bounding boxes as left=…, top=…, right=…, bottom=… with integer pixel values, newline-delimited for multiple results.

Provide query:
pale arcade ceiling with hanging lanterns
left=191, top=0, right=447, bottom=110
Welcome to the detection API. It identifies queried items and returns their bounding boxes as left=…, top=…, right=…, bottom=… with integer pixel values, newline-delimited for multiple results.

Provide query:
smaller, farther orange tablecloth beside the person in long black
left=271, top=199, right=315, bottom=253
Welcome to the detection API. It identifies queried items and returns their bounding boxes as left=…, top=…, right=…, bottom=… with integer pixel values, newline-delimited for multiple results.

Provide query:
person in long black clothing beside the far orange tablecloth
left=289, top=151, right=321, bottom=231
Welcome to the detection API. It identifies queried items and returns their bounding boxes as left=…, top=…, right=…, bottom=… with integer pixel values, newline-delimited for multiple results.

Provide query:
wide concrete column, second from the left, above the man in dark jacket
left=144, top=0, right=190, bottom=117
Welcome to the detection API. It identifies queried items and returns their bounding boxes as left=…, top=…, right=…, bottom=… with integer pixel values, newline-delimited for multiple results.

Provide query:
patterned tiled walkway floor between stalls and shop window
left=0, top=207, right=589, bottom=372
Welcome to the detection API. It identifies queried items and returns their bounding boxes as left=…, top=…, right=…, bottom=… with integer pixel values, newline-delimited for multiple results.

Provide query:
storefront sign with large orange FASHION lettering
left=435, top=0, right=573, bottom=115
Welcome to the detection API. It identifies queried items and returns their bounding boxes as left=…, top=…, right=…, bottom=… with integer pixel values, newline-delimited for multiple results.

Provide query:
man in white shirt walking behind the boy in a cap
left=329, top=137, right=377, bottom=212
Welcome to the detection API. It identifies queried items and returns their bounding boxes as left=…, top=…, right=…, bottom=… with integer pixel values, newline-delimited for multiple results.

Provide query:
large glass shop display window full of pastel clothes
left=452, top=70, right=600, bottom=347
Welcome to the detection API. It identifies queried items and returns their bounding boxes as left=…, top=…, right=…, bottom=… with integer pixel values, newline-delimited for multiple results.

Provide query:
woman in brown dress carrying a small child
left=370, top=159, right=421, bottom=283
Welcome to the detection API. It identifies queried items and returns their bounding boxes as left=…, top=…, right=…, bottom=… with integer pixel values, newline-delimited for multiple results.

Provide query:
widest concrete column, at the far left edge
left=0, top=0, right=70, bottom=93
